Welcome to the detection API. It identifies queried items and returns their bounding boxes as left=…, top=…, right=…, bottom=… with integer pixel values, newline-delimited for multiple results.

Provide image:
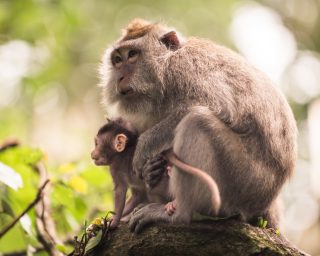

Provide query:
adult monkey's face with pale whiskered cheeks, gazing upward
left=102, top=42, right=163, bottom=112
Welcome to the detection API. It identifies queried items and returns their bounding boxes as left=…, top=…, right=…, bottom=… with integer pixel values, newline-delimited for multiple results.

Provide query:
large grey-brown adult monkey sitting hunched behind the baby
left=100, top=20, right=297, bottom=232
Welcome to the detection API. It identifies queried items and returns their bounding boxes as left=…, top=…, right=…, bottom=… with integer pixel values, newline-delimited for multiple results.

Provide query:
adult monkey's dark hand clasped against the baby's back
left=142, top=154, right=168, bottom=189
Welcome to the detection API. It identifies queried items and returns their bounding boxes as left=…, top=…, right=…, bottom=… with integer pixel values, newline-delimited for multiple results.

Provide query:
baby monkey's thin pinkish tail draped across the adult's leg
left=165, top=150, right=221, bottom=214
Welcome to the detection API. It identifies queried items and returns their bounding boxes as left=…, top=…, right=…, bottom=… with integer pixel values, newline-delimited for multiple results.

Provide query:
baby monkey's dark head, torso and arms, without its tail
left=91, top=119, right=147, bottom=228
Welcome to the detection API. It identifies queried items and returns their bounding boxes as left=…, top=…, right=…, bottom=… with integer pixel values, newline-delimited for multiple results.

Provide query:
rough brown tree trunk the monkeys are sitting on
left=95, top=220, right=307, bottom=256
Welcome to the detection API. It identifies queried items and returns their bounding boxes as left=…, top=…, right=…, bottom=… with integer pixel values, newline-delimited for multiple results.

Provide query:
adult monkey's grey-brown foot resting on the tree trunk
left=129, top=203, right=172, bottom=234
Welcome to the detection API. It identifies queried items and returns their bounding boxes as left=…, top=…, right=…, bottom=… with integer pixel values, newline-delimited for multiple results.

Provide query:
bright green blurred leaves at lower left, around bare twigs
left=0, top=147, right=112, bottom=253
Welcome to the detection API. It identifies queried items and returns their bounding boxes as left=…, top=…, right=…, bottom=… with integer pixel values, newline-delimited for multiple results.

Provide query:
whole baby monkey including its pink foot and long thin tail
left=91, top=118, right=221, bottom=228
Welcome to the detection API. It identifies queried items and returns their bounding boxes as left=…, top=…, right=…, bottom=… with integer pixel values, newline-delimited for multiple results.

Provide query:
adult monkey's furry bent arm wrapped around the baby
left=133, top=107, right=188, bottom=178
